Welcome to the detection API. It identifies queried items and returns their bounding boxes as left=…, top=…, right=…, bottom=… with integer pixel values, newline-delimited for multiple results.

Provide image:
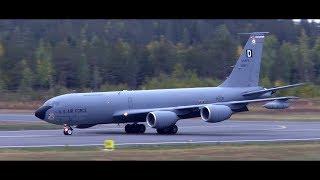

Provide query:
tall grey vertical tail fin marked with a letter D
left=219, top=32, right=269, bottom=87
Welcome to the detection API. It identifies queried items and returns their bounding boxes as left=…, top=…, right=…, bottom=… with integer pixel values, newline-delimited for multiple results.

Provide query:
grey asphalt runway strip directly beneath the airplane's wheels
left=0, top=119, right=320, bottom=148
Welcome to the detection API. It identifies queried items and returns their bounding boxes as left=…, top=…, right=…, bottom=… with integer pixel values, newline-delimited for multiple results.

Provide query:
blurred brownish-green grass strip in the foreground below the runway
left=0, top=142, right=320, bottom=161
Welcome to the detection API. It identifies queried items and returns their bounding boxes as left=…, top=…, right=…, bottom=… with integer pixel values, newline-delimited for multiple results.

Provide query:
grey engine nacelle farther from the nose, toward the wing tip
left=200, top=105, right=233, bottom=123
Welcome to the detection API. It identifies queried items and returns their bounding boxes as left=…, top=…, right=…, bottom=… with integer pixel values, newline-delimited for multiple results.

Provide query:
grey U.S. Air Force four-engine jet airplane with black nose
left=35, top=32, right=304, bottom=135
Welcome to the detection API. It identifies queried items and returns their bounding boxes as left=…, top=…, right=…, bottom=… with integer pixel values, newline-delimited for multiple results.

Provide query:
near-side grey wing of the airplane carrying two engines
left=113, top=96, right=299, bottom=120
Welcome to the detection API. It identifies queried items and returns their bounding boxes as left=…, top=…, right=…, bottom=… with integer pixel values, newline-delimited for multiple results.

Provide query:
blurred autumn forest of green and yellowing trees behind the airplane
left=0, top=19, right=320, bottom=101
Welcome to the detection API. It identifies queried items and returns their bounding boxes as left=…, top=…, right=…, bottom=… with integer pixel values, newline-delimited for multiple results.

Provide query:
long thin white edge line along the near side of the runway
left=0, top=138, right=320, bottom=149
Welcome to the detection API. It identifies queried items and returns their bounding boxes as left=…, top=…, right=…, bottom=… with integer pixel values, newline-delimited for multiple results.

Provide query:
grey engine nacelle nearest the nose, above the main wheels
left=146, top=111, right=179, bottom=129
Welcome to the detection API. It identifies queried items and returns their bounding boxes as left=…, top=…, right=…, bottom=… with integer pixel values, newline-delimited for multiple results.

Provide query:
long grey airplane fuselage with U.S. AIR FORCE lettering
left=38, top=87, right=262, bottom=125
